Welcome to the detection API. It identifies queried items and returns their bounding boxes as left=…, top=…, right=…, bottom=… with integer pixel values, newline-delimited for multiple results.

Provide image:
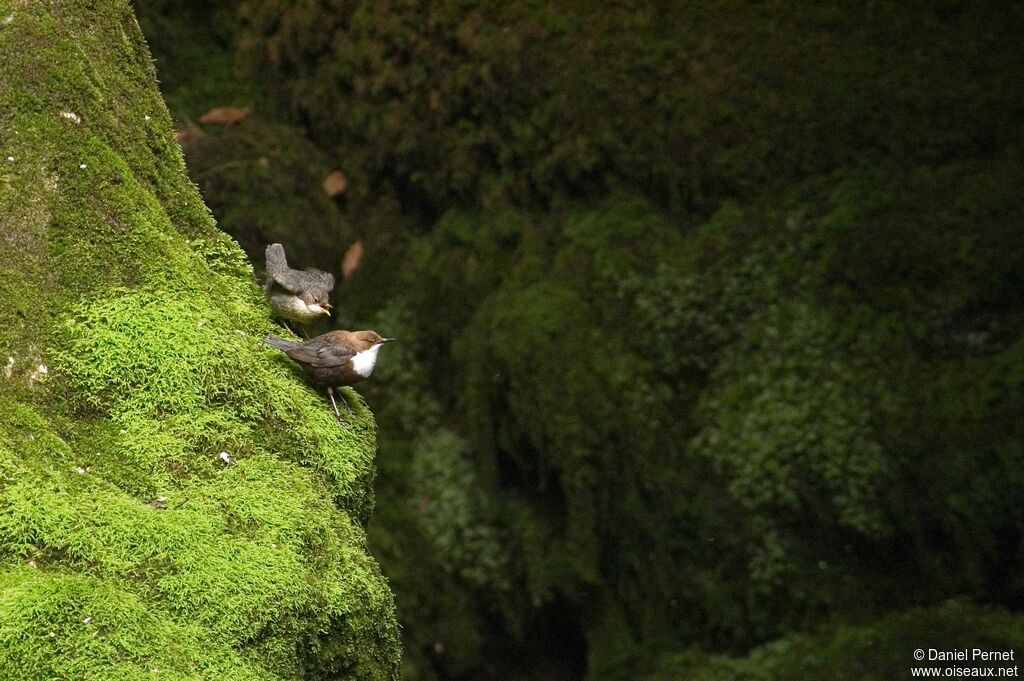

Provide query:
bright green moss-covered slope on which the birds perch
left=0, top=0, right=398, bottom=680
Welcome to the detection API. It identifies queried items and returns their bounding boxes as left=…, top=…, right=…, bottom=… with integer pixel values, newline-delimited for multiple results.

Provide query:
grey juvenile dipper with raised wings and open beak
left=263, top=244, right=334, bottom=327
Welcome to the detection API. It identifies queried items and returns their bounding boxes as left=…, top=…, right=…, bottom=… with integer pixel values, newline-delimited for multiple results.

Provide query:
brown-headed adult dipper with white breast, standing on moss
left=263, top=331, right=394, bottom=419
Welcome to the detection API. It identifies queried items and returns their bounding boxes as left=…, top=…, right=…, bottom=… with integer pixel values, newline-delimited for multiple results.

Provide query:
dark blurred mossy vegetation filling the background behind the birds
left=136, top=0, right=1024, bottom=681
